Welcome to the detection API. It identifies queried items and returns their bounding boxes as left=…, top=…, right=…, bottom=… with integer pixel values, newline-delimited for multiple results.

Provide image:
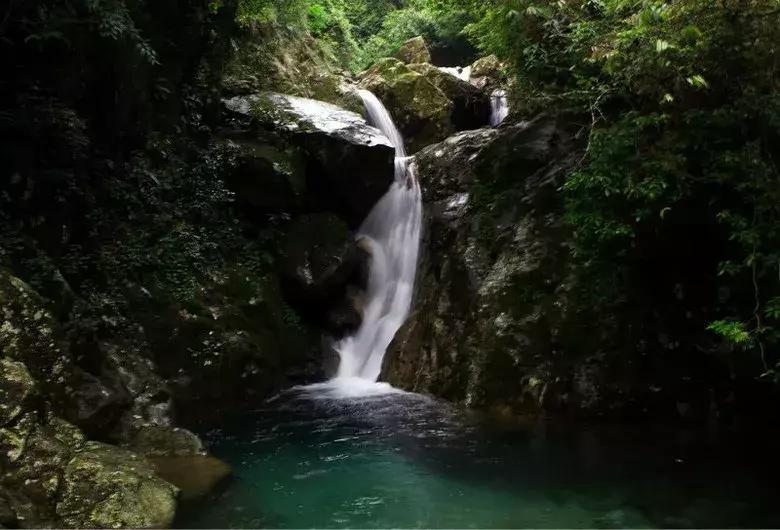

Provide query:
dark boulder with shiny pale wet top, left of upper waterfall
left=225, top=94, right=395, bottom=225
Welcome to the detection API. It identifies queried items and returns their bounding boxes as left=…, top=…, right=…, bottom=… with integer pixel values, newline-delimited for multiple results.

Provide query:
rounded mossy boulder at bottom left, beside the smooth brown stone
left=57, top=442, right=179, bottom=528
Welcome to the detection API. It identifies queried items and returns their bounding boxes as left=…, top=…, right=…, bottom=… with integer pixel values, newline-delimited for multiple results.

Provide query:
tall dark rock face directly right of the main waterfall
left=383, top=116, right=630, bottom=414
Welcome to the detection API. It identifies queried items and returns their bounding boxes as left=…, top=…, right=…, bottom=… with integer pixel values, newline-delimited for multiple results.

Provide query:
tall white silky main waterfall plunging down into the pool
left=336, top=90, right=422, bottom=382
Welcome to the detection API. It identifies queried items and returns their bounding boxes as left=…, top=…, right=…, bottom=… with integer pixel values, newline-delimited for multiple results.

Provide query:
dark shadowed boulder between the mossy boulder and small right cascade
left=409, top=63, right=490, bottom=131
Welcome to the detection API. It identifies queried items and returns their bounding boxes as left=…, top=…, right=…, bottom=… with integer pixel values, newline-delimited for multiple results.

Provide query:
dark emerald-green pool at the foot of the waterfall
left=179, top=384, right=780, bottom=528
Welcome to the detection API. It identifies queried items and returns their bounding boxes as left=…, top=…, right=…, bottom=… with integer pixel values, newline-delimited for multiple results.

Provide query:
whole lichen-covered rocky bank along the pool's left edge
left=0, top=270, right=219, bottom=528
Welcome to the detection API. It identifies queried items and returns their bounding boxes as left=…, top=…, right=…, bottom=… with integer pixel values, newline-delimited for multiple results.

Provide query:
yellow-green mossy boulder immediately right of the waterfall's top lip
left=360, top=58, right=455, bottom=153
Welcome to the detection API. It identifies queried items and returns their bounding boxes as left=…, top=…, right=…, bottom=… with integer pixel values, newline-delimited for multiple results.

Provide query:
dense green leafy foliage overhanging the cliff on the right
left=452, top=0, right=780, bottom=374
